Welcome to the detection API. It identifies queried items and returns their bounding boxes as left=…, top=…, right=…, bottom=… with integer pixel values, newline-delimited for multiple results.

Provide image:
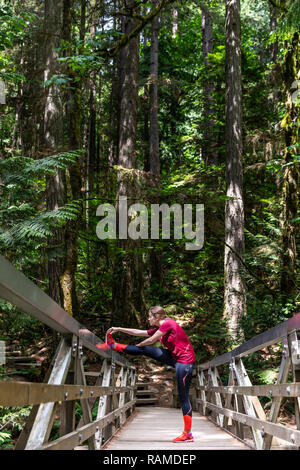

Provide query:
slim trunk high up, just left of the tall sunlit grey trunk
left=201, top=5, right=218, bottom=165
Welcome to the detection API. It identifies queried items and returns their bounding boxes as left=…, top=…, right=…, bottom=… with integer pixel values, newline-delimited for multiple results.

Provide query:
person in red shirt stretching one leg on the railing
left=97, top=306, right=196, bottom=442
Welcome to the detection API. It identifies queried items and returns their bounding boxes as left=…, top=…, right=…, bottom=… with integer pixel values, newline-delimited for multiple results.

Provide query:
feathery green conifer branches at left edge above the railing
left=0, top=152, right=80, bottom=258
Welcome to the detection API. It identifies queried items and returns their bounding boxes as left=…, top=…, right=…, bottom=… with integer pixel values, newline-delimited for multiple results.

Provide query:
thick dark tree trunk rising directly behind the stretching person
left=112, top=4, right=145, bottom=325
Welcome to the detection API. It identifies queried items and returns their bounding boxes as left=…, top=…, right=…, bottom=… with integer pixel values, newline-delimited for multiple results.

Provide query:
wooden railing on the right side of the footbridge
left=197, top=314, right=300, bottom=450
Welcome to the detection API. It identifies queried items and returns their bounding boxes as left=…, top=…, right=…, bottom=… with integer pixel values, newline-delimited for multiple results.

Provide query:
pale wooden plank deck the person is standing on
left=99, top=406, right=249, bottom=450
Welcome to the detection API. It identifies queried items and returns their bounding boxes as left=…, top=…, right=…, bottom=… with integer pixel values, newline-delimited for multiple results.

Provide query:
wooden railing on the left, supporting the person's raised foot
left=0, top=256, right=136, bottom=450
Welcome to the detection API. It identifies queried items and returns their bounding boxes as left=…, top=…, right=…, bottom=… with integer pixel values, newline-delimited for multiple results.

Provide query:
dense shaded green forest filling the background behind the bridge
left=0, top=0, right=300, bottom=392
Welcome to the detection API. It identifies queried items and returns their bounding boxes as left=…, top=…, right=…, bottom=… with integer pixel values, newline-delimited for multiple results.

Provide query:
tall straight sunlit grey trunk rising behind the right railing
left=224, top=0, right=246, bottom=341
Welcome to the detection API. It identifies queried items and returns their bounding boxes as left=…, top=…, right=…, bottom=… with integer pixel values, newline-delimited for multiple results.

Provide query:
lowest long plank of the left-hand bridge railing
left=37, top=402, right=133, bottom=450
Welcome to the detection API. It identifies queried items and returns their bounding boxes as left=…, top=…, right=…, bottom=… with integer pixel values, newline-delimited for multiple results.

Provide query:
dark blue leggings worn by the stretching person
left=123, top=345, right=194, bottom=416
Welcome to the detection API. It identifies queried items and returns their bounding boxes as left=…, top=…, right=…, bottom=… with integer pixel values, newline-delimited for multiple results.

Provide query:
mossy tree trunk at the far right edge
left=281, top=32, right=300, bottom=295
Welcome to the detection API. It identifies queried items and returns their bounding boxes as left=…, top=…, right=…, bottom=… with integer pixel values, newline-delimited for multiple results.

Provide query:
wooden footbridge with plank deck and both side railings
left=0, top=256, right=300, bottom=450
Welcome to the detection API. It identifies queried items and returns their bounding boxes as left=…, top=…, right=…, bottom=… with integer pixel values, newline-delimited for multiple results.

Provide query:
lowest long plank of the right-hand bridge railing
left=198, top=399, right=300, bottom=446
